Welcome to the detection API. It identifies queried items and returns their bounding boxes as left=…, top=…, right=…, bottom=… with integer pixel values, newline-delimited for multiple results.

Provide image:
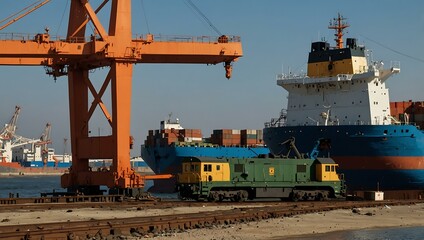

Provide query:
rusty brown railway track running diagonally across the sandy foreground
left=0, top=200, right=423, bottom=239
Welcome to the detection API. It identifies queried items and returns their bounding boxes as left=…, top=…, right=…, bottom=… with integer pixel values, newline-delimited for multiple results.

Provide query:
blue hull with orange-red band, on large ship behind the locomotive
left=264, top=125, right=424, bottom=190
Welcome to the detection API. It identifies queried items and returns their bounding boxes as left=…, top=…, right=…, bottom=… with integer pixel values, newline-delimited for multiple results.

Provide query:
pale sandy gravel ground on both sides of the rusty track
left=0, top=204, right=424, bottom=240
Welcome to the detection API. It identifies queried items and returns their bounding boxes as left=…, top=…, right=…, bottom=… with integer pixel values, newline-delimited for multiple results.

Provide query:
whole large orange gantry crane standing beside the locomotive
left=0, top=0, right=242, bottom=194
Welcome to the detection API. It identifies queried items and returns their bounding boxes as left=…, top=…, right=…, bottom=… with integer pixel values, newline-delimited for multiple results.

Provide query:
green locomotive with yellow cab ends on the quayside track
left=177, top=156, right=346, bottom=201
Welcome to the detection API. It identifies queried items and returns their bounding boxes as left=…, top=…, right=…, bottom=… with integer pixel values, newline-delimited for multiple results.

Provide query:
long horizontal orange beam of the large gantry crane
left=0, top=39, right=243, bottom=68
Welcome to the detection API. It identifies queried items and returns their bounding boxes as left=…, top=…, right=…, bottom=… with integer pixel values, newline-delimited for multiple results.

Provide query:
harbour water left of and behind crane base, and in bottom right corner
left=0, top=176, right=424, bottom=240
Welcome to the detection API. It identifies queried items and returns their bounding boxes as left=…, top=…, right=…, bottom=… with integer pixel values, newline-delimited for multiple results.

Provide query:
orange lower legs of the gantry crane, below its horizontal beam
left=62, top=62, right=144, bottom=194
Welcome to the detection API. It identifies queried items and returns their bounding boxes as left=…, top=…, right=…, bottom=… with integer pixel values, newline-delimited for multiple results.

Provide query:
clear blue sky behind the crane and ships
left=0, top=0, right=424, bottom=156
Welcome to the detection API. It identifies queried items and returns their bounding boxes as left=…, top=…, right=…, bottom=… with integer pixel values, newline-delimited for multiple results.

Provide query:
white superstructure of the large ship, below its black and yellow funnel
left=277, top=61, right=400, bottom=126
